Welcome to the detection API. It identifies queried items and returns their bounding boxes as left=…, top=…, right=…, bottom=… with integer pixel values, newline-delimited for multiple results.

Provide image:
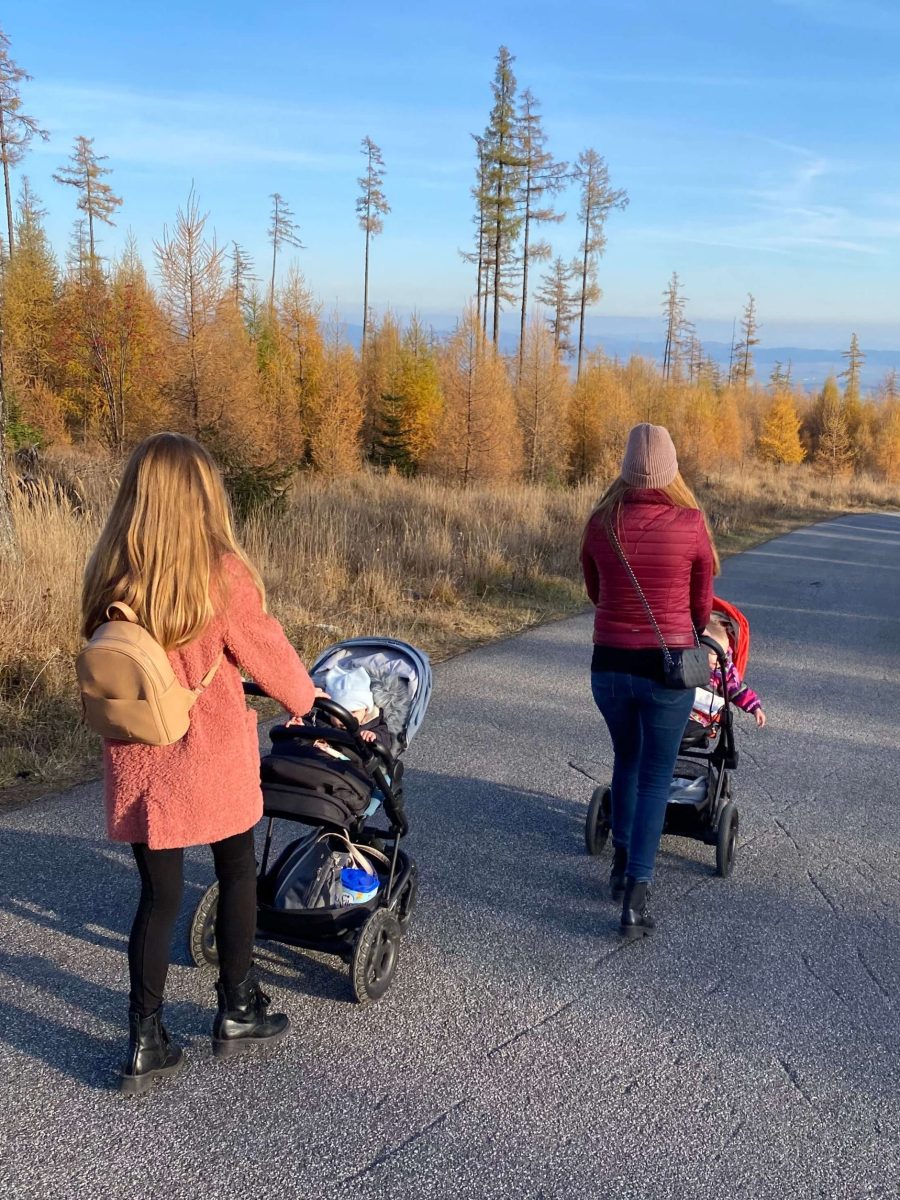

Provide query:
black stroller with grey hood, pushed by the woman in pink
left=190, top=637, right=432, bottom=1004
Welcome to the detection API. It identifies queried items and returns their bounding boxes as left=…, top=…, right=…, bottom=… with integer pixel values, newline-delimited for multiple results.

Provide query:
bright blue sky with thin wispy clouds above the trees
left=2, top=0, right=900, bottom=347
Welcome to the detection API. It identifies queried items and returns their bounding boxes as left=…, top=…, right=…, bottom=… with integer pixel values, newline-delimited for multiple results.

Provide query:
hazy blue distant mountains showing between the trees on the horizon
left=344, top=318, right=900, bottom=392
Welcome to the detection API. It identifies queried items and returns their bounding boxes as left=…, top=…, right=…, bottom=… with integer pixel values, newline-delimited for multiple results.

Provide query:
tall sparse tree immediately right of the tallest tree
left=518, top=89, right=569, bottom=376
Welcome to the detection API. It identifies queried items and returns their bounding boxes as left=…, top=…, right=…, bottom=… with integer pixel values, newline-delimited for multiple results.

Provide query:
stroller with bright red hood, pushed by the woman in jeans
left=584, top=596, right=750, bottom=877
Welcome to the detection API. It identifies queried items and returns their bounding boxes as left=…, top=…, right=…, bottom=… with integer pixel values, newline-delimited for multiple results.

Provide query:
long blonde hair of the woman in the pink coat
left=82, top=433, right=265, bottom=650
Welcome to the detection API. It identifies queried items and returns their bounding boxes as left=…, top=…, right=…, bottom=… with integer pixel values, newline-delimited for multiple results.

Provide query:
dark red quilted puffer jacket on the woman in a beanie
left=581, top=488, right=713, bottom=649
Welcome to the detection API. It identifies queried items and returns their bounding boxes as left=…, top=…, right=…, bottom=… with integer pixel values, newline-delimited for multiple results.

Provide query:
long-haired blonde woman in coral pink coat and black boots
left=82, top=433, right=316, bottom=1092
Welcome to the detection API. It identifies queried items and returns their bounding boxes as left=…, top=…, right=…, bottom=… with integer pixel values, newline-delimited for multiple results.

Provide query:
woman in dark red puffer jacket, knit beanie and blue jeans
left=581, top=425, right=719, bottom=937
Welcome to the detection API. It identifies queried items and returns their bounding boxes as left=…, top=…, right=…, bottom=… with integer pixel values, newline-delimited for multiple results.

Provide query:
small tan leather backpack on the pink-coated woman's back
left=76, top=600, right=222, bottom=746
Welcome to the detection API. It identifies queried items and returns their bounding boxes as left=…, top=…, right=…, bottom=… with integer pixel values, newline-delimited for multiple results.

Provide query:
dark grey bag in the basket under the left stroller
left=274, top=830, right=389, bottom=911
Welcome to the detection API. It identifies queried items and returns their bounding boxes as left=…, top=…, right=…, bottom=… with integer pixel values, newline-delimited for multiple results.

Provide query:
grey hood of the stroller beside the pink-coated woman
left=310, top=637, right=431, bottom=748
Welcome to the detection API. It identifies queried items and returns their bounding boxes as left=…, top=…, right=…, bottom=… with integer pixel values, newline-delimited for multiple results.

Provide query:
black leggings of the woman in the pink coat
left=128, top=829, right=257, bottom=1016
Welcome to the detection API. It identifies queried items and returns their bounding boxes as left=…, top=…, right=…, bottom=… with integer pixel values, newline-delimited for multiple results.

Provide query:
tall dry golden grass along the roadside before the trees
left=0, top=464, right=900, bottom=796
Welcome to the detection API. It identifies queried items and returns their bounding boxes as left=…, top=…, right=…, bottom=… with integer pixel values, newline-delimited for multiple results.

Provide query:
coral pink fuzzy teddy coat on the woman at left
left=103, top=554, right=314, bottom=850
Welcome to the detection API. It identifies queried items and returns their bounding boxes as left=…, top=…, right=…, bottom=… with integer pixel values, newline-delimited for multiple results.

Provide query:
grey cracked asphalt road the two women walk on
left=0, top=515, right=900, bottom=1200
